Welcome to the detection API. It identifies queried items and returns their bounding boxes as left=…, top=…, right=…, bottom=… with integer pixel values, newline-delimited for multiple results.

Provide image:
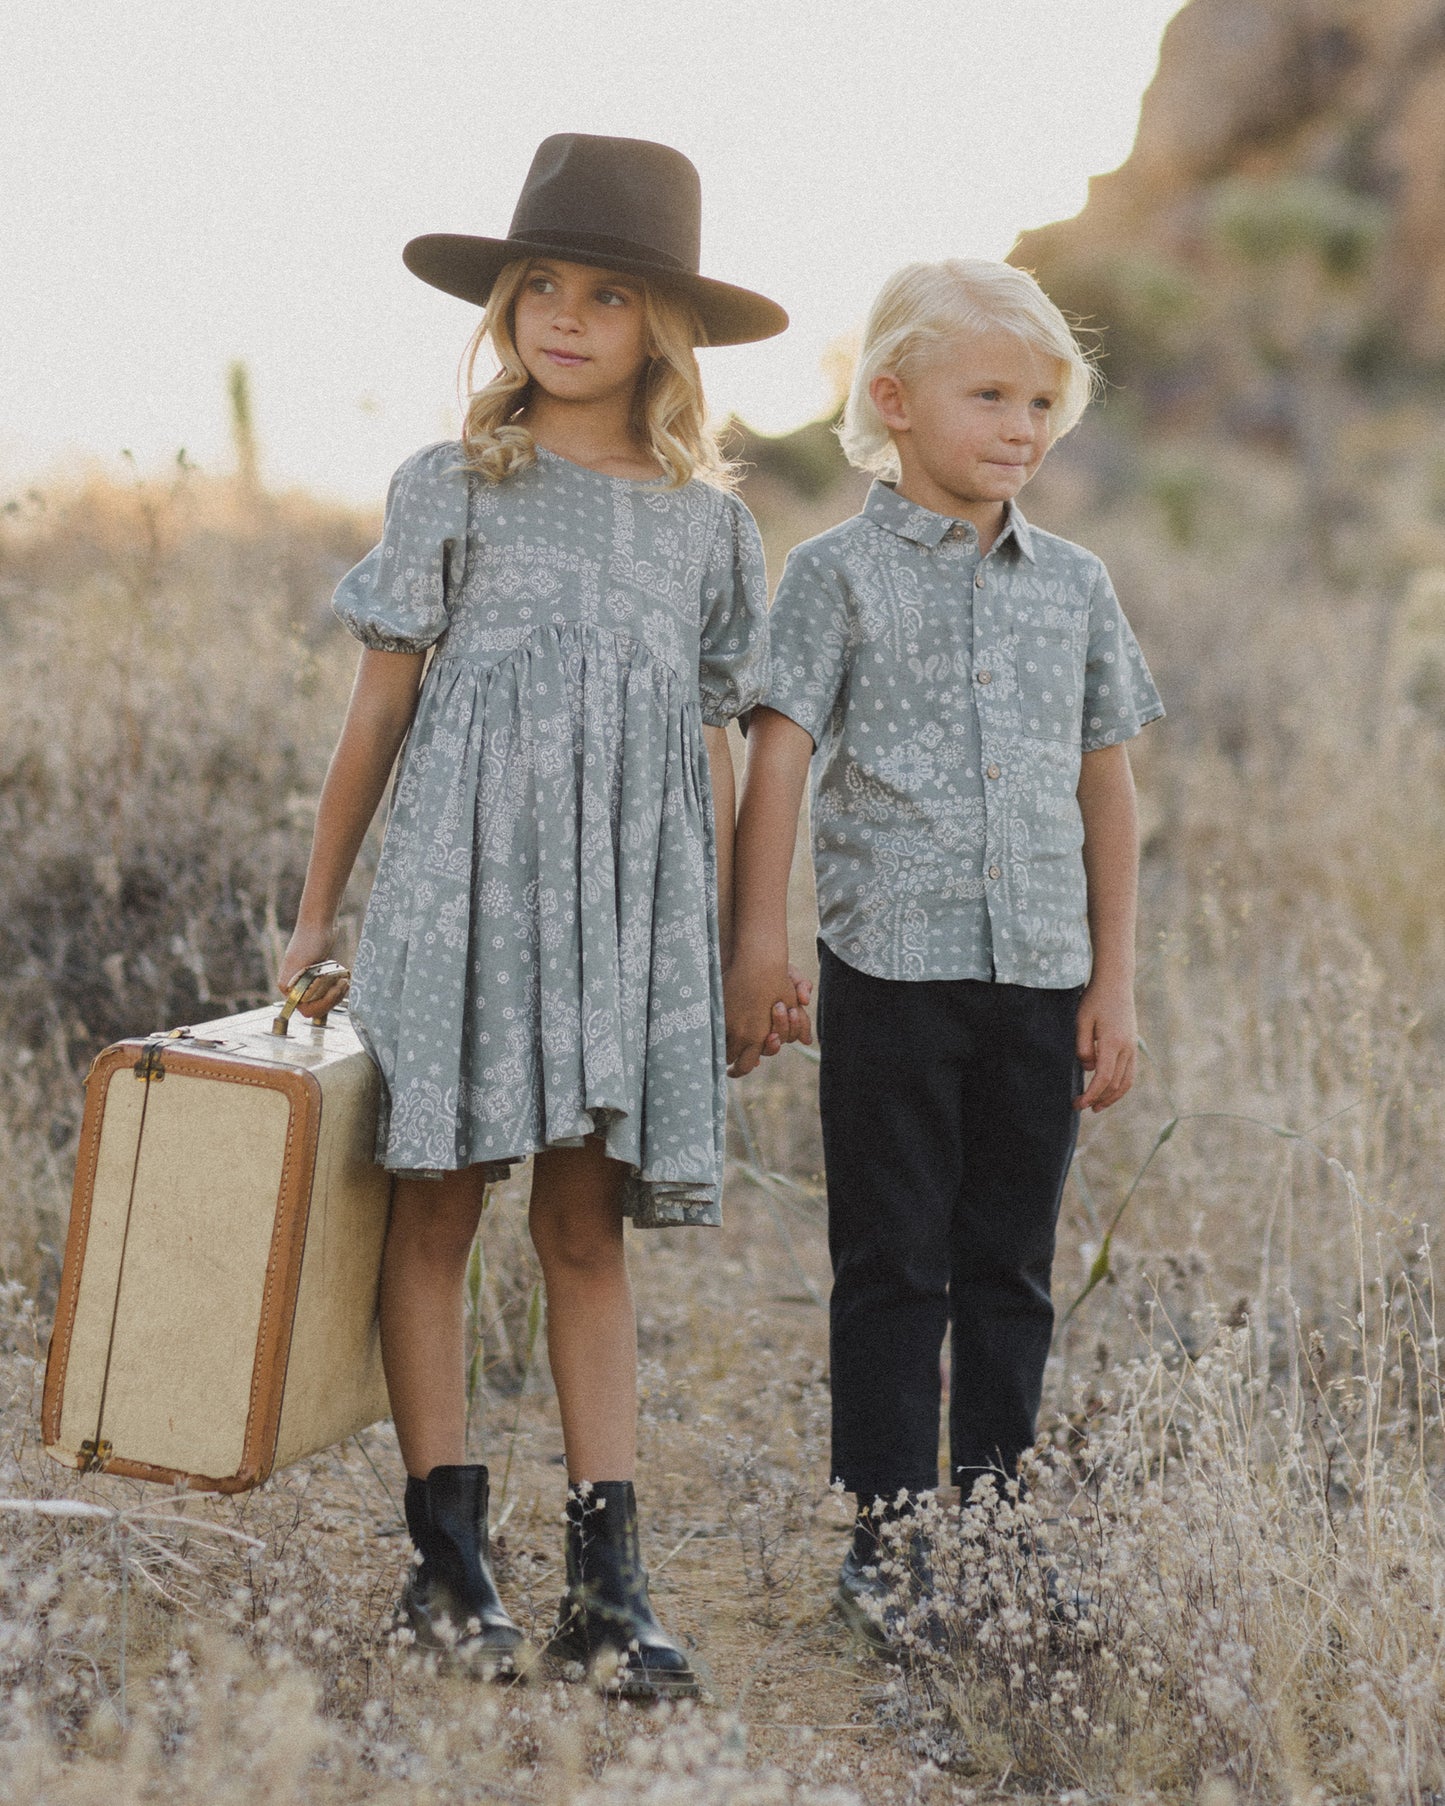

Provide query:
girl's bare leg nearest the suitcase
left=381, top=1167, right=486, bottom=1479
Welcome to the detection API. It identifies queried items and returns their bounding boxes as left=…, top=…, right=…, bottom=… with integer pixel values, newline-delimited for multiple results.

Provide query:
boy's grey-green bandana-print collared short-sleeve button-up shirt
left=768, top=482, right=1163, bottom=990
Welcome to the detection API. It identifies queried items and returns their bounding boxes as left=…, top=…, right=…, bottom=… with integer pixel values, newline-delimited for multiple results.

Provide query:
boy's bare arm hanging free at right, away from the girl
left=1075, top=744, right=1140, bottom=1111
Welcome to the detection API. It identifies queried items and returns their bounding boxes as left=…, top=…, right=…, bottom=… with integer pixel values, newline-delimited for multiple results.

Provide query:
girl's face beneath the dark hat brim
left=513, top=258, right=647, bottom=403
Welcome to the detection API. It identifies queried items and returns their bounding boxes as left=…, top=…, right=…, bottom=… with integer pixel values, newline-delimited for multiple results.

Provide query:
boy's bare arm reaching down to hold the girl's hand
left=723, top=708, right=813, bottom=1078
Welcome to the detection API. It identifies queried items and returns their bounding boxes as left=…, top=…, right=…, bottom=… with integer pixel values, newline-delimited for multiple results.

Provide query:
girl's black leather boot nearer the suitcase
left=401, top=1466, right=522, bottom=1678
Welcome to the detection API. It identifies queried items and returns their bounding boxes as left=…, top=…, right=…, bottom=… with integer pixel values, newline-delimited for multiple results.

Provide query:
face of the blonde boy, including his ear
left=871, top=330, right=1062, bottom=527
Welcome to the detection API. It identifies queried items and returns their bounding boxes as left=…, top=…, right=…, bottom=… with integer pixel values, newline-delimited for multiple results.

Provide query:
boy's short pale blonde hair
left=838, top=258, right=1098, bottom=479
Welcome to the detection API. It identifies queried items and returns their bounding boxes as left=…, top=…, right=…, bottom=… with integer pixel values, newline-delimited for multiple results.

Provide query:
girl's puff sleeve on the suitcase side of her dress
left=331, top=441, right=468, bottom=652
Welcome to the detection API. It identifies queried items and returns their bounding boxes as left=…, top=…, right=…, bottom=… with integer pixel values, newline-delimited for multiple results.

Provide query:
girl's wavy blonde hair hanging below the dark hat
left=462, top=258, right=735, bottom=489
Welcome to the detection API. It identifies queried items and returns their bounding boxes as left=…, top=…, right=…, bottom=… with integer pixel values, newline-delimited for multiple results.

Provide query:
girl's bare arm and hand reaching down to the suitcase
left=278, top=648, right=426, bottom=1015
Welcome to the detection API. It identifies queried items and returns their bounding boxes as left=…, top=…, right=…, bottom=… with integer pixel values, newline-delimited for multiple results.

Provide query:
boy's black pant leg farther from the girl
left=948, top=984, right=1080, bottom=1497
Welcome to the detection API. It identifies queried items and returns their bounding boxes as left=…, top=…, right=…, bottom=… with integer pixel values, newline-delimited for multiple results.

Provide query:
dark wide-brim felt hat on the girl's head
left=401, top=132, right=788, bottom=345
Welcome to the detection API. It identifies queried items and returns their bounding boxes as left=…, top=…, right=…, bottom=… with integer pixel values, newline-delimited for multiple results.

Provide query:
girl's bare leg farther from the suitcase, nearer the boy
left=531, top=1145, right=638, bottom=1481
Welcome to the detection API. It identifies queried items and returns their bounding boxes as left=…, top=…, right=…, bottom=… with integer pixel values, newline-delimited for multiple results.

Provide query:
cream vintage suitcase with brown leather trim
left=42, top=966, right=390, bottom=1492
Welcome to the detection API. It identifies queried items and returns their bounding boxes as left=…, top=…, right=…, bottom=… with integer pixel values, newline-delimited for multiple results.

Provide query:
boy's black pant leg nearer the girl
left=818, top=945, right=963, bottom=1497
